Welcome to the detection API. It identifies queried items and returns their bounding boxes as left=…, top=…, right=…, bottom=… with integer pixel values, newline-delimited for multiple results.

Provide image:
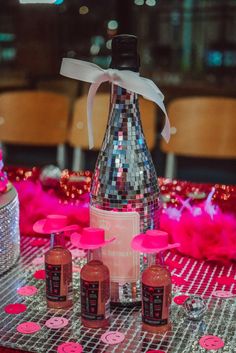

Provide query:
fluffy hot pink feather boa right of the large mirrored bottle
left=161, top=208, right=236, bottom=263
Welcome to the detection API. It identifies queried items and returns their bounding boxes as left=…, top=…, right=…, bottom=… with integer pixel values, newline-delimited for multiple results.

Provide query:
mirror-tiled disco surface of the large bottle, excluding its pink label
left=90, top=85, right=160, bottom=304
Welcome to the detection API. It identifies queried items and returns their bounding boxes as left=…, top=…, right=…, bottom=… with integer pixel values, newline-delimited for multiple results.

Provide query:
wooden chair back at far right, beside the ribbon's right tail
left=161, top=97, right=236, bottom=178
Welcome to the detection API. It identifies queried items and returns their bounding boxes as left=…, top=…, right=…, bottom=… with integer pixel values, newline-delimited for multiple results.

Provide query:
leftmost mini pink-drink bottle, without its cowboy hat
left=45, top=233, right=73, bottom=309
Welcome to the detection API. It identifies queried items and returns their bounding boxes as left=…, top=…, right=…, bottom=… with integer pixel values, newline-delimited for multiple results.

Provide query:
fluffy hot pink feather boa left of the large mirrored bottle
left=14, top=181, right=89, bottom=236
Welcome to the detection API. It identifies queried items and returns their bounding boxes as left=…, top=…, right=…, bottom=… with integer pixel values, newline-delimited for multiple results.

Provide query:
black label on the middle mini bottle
left=80, top=278, right=105, bottom=320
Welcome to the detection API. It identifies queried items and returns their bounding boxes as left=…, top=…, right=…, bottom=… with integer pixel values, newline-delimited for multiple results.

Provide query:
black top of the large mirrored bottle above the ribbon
left=110, top=34, right=140, bottom=72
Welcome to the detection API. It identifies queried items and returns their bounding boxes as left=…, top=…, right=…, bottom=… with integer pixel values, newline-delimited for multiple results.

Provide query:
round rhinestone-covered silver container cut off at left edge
left=0, top=187, right=20, bottom=274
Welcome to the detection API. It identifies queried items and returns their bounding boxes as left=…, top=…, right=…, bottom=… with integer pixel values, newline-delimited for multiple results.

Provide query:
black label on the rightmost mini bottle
left=142, top=284, right=168, bottom=326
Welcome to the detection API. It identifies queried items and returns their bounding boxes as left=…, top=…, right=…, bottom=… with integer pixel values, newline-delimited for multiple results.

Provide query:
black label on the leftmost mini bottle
left=45, top=263, right=67, bottom=302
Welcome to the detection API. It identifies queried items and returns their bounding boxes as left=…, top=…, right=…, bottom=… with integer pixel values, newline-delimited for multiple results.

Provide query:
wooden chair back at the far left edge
left=0, top=91, right=69, bottom=168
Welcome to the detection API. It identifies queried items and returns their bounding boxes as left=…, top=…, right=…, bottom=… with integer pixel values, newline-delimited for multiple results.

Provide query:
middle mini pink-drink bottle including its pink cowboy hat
left=71, top=227, right=115, bottom=328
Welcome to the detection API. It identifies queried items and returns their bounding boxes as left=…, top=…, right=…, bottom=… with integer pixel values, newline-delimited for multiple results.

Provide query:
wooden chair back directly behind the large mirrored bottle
left=68, top=93, right=156, bottom=170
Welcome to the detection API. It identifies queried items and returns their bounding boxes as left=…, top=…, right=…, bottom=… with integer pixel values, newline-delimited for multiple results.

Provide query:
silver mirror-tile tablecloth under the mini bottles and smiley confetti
left=0, top=237, right=236, bottom=353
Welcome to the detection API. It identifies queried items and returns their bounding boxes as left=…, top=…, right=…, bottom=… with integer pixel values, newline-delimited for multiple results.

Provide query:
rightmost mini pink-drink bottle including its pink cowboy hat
left=132, top=230, right=179, bottom=333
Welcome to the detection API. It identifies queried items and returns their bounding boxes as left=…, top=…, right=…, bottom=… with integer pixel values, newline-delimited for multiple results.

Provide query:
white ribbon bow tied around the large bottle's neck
left=60, top=58, right=170, bottom=148
